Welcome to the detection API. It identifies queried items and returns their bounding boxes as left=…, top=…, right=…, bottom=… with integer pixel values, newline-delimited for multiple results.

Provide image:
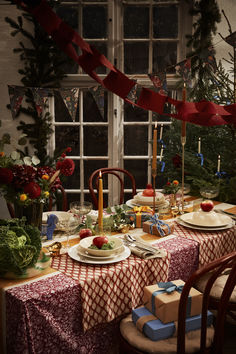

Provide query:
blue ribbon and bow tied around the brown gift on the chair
left=151, top=281, right=192, bottom=317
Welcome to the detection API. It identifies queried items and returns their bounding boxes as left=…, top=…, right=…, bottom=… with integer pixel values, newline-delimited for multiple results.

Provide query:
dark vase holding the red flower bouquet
left=14, top=203, right=43, bottom=231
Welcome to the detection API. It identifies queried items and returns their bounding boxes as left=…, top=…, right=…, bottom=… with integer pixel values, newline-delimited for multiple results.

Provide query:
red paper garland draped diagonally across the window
left=14, top=0, right=236, bottom=126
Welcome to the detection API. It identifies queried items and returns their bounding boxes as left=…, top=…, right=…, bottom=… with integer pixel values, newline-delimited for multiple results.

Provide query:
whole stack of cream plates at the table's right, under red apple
left=177, top=211, right=235, bottom=231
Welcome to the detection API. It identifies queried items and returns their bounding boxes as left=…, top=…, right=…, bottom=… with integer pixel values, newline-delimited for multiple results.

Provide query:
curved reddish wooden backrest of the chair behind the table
left=88, top=167, right=136, bottom=209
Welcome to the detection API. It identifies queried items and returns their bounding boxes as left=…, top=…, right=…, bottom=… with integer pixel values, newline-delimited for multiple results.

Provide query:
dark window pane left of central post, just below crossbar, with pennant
left=83, top=86, right=107, bottom=122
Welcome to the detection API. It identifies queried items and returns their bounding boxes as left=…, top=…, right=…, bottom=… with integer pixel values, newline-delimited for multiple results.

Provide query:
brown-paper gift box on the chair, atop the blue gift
left=143, top=280, right=202, bottom=323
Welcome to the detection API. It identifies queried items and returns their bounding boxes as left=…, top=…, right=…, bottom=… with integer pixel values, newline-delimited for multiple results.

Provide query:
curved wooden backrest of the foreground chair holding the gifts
left=177, top=251, right=236, bottom=354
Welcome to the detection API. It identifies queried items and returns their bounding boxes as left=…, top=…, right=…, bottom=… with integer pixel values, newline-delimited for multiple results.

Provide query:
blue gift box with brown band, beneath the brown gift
left=132, top=307, right=213, bottom=341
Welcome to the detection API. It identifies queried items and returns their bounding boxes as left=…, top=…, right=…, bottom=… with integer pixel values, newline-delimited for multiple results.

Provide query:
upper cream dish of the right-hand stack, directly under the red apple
left=180, top=211, right=232, bottom=228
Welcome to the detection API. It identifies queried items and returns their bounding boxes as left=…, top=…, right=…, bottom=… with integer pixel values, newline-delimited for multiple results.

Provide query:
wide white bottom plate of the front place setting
left=68, top=245, right=131, bottom=265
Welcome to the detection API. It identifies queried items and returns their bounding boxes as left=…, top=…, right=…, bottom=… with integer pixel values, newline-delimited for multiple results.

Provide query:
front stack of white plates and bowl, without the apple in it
left=68, top=236, right=131, bottom=264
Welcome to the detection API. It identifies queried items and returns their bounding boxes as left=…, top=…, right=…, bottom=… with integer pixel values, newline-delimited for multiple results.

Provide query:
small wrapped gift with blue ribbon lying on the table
left=143, top=217, right=175, bottom=237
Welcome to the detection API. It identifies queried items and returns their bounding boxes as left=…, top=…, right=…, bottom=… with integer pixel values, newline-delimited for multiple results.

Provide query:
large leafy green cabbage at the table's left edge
left=0, top=219, right=42, bottom=274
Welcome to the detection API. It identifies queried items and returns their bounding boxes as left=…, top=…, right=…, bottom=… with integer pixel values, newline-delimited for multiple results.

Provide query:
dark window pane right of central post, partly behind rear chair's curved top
left=124, top=160, right=148, bottom=189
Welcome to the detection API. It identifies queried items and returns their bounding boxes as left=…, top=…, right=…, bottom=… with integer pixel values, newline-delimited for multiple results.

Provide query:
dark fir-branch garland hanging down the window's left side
left=5, top=1, right=71, bottom=166
